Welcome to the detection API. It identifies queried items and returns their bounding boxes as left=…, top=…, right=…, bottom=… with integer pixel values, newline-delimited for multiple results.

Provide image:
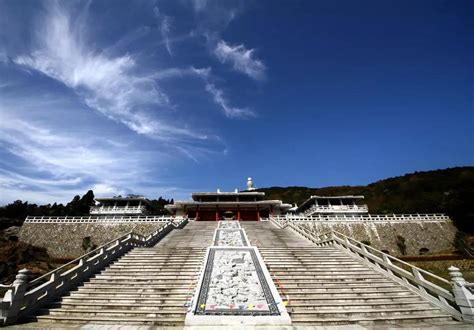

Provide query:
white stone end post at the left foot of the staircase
left=1, top=268, right=31, bottom=325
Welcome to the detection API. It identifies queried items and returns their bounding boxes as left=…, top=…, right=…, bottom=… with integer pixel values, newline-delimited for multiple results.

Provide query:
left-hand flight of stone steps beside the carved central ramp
left=26, top=223, right=217, bottom=326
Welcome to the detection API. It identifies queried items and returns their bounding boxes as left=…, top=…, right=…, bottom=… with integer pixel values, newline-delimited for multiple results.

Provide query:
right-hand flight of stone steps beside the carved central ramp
left=242, top=222, right=459, bottom=326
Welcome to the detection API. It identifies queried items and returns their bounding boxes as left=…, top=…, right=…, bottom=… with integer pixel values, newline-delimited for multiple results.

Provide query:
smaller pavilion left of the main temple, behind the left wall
left=90, top=196, right=151, bottom=217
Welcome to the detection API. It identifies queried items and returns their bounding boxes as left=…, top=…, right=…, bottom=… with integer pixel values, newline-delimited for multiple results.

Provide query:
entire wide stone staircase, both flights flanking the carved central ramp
left=19, top=222, right=459, bottom=328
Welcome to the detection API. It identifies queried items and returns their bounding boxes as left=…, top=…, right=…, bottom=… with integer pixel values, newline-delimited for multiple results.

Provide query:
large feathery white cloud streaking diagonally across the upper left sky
left=14, top=3, right=202, bottom=140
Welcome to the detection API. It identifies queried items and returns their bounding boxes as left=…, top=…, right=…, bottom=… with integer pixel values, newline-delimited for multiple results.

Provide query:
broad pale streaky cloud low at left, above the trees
left=0, top=108, right=176, bottom=203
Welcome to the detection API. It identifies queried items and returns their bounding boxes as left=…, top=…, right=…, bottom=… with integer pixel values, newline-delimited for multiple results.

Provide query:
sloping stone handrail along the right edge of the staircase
left=270, top=217, right=464, bottom=320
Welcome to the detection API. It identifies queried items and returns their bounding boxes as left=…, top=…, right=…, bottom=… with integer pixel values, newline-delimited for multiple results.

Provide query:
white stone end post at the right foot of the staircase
left=448, top=266, right=474, bottom=323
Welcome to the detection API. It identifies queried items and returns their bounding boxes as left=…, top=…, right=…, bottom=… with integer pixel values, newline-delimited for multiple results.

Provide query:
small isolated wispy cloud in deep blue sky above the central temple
left=214, top=40, right=266, bottom=80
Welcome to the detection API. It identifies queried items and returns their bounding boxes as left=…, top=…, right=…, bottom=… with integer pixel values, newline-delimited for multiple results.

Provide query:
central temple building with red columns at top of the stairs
left=165, top=187, right=291, bottom=221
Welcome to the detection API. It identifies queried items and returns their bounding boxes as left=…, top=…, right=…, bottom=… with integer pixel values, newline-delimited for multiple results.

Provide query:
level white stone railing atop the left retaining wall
left=25, top=215, right=184, bottom=223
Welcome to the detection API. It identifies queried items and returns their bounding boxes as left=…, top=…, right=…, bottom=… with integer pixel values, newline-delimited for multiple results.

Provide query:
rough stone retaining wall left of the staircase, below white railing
left=19, top=222, right=166, bottom=258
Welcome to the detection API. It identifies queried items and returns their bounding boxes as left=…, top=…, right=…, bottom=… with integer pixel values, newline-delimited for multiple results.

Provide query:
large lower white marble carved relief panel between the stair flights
left=205, top=250, right=269, bottom=311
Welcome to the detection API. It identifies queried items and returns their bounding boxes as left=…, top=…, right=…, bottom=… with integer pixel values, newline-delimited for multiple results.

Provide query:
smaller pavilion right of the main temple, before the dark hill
left=295, top=195, right=369, bottom=216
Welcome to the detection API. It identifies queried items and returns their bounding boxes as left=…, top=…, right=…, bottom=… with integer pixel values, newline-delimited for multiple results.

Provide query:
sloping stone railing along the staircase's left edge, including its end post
left=0, top=219, right=187, bottom=325
